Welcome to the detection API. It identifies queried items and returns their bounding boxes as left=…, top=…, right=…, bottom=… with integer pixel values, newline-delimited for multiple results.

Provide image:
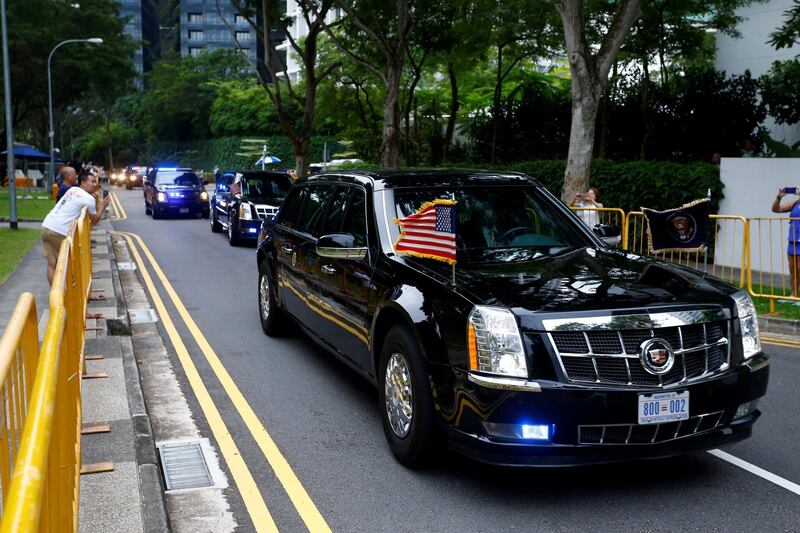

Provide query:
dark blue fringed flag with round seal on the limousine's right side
left=642, top=198, right=711, bottom=254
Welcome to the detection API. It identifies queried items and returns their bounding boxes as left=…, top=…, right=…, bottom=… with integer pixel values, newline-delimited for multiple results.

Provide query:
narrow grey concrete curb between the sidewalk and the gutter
left=106, top=233, right=171, bottom=532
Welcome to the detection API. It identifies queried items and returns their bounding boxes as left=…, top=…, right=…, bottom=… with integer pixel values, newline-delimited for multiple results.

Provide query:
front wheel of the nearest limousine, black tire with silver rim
left=378, top=325, right=442, bottom=469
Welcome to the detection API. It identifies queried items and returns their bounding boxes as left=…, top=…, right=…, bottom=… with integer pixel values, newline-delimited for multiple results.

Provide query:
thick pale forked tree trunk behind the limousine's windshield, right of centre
left=557, top=0, right=641, bottom=202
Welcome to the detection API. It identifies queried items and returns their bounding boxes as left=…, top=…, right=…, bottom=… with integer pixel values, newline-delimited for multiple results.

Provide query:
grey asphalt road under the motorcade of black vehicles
left=112, top=188, right=800, bottom=532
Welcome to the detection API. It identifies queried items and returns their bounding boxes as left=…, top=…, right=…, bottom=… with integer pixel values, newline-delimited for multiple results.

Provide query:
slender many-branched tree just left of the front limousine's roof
left=223, top=0, right=336, bottom=176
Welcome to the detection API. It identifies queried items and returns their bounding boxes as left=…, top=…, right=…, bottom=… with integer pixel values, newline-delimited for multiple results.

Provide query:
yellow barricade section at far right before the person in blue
left=747, top=217, right=800, bottom=304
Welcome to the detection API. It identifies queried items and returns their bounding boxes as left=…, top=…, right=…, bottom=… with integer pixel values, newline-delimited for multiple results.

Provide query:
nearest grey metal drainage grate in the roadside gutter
left=158, top=439, right=227, bottom=490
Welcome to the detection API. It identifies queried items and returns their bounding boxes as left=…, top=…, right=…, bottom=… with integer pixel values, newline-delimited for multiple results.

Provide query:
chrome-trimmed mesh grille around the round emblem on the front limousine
left=548, top=320, right=730, bottom=387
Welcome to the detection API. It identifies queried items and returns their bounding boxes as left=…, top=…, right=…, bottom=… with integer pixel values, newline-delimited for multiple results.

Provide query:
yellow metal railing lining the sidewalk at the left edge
left=0, top=211, right=92, bottom=533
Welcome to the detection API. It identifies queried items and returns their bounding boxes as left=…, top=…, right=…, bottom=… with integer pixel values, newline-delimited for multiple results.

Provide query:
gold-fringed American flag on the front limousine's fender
left=394, top=199, right=456, bottom=265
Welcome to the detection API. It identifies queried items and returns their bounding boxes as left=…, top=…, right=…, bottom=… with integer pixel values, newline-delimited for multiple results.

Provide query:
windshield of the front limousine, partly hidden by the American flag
left=395, top=187, right=594, bottom=263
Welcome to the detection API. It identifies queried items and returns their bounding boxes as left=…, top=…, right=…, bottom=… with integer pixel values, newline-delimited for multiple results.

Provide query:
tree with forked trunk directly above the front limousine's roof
left=328, top=0, right=415, bottom=167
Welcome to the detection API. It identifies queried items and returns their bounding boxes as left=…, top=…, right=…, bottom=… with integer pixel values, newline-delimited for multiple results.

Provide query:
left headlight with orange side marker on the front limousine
left=467, top=305, right=528, bottom=378
